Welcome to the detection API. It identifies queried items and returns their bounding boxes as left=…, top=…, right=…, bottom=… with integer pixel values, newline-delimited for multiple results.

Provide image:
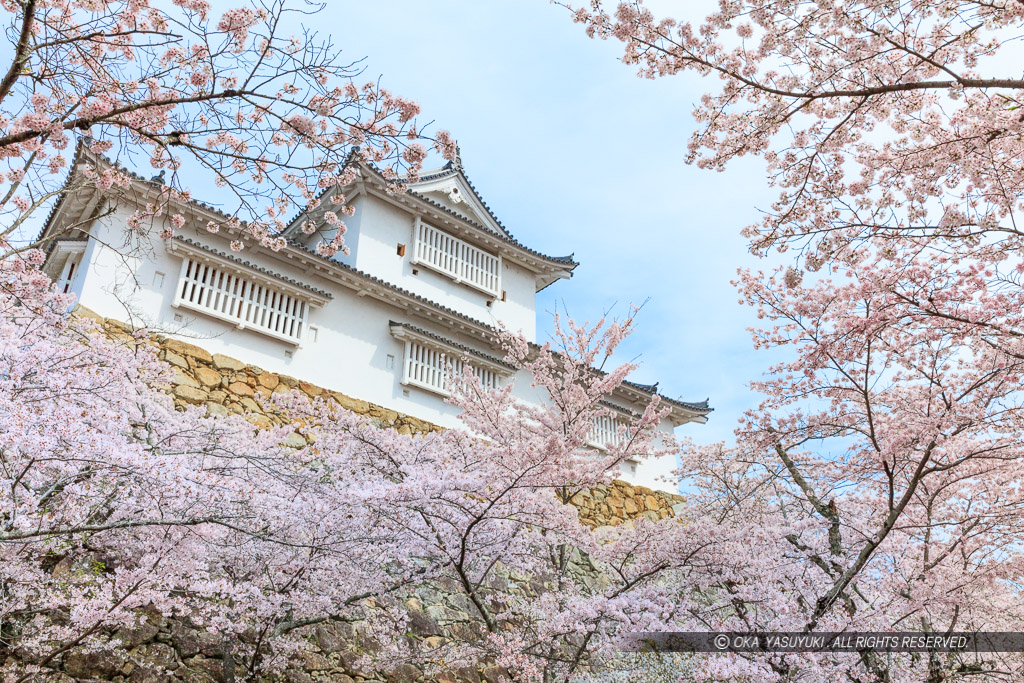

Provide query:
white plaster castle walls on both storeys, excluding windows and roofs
left=68, top=198, right=675, bottom=490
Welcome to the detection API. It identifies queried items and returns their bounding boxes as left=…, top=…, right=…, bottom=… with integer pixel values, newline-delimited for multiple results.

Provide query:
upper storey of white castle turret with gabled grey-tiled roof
left=289, top=154, right=578, bottom=339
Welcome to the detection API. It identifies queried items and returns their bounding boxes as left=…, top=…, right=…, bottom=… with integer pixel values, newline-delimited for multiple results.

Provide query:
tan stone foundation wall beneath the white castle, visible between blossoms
left=6, top=309, right=683, bottom=683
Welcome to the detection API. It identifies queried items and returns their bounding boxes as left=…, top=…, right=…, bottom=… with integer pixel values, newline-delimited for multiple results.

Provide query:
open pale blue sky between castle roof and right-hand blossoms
left=325, top=0, right=772, bottom=442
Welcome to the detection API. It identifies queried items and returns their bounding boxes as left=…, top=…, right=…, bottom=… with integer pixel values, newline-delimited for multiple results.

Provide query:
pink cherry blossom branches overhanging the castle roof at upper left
left=0, top=0, right=455, bottom=258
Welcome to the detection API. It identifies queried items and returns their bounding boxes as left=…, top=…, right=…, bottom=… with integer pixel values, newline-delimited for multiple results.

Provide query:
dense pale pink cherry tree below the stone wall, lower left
left=0, top=252, right=425, bottom=681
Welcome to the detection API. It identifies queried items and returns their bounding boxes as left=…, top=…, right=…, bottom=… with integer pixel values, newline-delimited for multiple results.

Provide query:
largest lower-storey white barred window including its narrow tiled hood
left=169, top=242, right=327, bottom=347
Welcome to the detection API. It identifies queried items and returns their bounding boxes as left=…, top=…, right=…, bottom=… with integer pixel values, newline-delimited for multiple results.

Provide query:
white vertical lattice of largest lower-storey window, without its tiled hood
left=174, top=258, right=308, bottom=344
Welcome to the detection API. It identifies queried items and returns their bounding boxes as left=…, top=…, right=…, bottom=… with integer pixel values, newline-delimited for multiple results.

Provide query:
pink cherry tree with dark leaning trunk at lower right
left=671, top=269, right=1024, bottom=681
